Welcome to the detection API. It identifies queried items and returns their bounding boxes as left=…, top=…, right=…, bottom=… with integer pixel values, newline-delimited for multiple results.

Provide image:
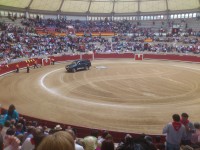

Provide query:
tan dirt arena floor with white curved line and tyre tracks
left=0, top=59, right=200, bottom=134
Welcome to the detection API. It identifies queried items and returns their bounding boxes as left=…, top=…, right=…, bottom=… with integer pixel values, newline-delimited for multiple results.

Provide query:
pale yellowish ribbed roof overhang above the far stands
left=0, top=0, right=200, bottom=16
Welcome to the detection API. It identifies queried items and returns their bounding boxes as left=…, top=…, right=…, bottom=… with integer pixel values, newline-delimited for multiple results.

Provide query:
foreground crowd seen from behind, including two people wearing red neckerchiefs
left=0, top=105, right=200, bottom=150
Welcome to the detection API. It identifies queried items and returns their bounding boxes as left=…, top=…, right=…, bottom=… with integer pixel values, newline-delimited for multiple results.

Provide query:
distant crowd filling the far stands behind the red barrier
left=0, top=19, right=200, bottom=65
